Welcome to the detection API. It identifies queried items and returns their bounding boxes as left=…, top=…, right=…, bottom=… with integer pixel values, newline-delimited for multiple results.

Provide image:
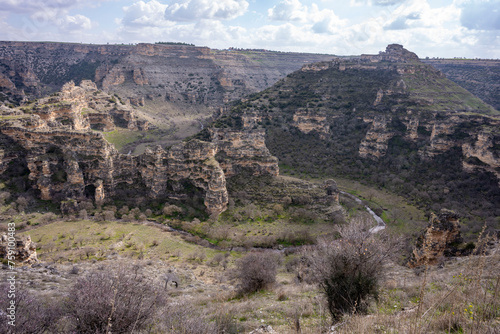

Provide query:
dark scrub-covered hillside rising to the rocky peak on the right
left=203, top=45, right=500, bottom=236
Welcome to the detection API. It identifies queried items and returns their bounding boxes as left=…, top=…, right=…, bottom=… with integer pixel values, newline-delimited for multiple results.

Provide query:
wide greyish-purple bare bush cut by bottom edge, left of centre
left=66, top=267, right=163, bottom=333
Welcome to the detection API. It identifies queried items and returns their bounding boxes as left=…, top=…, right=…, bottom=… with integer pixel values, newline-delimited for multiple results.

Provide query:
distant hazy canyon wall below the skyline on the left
left=0, top=42, right=332, bottom=106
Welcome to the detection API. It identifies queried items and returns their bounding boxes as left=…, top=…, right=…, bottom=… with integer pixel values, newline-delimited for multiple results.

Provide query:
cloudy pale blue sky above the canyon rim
left=0, top=0, right=500, bottom=59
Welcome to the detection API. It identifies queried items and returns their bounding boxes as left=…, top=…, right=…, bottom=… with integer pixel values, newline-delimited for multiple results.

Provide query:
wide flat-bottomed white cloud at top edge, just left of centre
left=165, top=0, right=248, bottom=21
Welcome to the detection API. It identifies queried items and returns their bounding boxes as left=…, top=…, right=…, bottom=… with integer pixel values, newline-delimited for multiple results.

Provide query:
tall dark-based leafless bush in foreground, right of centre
left=304, top=220, right=399, bottom=322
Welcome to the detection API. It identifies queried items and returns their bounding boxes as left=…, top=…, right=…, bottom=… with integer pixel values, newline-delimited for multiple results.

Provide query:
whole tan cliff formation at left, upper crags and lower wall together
left=0, top=81, right=278, bottom=214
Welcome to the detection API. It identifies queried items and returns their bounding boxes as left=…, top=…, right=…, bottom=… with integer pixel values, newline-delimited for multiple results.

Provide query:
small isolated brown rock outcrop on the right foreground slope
left=409, top=209, right=463, bottom=267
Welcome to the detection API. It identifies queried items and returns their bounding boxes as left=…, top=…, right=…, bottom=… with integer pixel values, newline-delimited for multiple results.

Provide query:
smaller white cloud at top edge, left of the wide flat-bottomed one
left=121, top=0, right=168, bottom=27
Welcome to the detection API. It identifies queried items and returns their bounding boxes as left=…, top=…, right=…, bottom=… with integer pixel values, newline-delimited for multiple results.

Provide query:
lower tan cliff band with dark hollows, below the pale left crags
left=2, top=127, right=228, bottom=214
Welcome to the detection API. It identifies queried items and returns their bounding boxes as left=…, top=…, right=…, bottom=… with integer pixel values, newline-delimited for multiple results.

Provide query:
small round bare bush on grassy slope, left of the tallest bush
left=236, top=253, right=278, bottom=293
